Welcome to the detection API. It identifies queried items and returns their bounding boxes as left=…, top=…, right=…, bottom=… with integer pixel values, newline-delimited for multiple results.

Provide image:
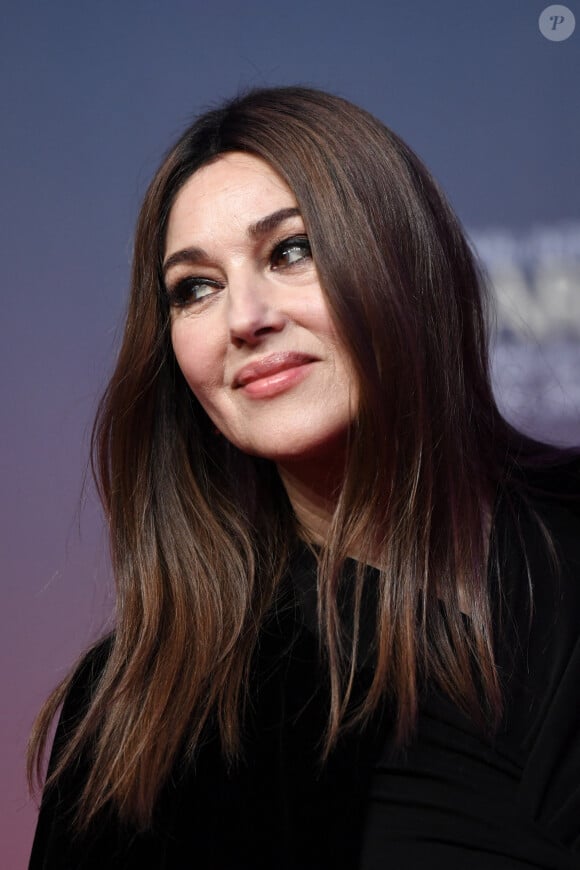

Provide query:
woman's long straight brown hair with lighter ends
left=30, top=88, right=556, bottom=826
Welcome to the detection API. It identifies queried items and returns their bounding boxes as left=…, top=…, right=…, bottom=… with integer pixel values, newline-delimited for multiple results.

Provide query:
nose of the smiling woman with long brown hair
left=227, top=270, right=287, bottom=347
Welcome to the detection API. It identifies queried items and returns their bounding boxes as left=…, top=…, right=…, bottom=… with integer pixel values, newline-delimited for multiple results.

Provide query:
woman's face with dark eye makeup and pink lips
left=164, top=152, right=357, bottom=474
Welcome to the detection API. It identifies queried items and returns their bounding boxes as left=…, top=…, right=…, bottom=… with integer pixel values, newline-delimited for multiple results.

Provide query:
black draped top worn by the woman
left=30, top=466, right=580, bottom=870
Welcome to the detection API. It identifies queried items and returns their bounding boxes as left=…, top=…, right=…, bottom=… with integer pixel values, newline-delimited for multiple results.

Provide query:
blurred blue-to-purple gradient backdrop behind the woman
left=0, top=0, right=580, bottom=870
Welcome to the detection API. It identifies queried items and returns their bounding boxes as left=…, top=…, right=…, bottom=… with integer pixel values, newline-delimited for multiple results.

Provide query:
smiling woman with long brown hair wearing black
left=31, top=88, right=580, bottom=868
